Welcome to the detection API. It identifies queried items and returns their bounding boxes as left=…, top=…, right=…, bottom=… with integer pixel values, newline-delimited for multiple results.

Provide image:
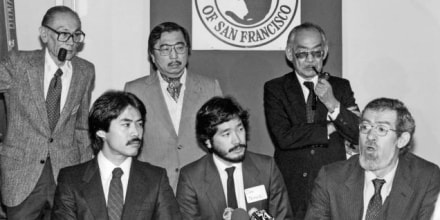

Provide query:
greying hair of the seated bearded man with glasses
left=362, top=98, right=416, bottom=153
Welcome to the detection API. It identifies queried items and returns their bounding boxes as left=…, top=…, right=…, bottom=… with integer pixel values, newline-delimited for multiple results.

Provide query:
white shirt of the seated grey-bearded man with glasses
left=362, top=161, right=399, bottom=220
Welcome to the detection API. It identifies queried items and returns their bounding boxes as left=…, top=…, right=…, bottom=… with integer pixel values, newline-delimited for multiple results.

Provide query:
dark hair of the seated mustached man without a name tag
left=89, top=91, right=147, bottom=154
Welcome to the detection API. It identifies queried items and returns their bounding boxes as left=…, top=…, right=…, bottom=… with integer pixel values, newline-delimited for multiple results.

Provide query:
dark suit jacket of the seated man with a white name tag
left=177, top=152, right=292, bottom=220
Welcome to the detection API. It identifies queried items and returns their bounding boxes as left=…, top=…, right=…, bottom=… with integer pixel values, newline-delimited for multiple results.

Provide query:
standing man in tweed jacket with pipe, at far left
left=0, top=6, right=95, bottom=219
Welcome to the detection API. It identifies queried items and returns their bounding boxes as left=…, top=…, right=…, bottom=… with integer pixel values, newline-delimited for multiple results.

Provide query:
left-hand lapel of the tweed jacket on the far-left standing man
left=26, top=50, right=50, bottom=132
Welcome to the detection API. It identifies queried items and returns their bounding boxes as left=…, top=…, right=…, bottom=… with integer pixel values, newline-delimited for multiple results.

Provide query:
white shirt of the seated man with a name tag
left=212, top=154, right=247, bottom=210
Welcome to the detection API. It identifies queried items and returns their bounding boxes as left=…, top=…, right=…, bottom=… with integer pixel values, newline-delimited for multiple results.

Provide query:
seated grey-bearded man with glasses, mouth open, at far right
left=306, top=98, right=440, bottom=220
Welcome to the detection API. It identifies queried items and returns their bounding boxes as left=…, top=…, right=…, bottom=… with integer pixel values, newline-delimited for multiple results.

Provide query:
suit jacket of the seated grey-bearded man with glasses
left=306, top=153, right=440, bottom=220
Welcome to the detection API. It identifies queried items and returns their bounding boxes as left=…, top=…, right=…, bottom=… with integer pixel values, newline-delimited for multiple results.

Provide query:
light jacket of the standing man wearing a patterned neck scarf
left=125, top=71, right=222, bottom=191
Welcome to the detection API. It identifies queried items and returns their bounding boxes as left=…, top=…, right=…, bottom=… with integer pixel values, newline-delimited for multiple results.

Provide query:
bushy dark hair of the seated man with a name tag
left=196, top=96, right=249, bottom=150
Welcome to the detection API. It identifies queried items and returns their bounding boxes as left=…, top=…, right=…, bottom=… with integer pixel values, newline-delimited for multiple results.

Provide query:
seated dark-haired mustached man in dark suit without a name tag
left=52, top=91, right=180, bottom=220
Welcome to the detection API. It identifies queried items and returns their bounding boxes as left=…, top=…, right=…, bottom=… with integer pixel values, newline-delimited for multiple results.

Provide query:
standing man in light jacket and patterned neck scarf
left=125, top=22, right=222, bottom=192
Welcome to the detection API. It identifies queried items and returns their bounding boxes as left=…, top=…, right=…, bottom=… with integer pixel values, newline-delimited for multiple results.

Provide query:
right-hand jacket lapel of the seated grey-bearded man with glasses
left=384, top=157, right=414, bottom=219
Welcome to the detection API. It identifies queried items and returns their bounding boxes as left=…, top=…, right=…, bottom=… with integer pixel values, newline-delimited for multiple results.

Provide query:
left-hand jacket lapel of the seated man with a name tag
left=202, top=154, right=226, bottom=216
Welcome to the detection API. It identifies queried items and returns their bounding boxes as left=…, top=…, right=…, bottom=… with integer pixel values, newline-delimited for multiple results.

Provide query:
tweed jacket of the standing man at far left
left=0, top=50, right=95, bottom=206
